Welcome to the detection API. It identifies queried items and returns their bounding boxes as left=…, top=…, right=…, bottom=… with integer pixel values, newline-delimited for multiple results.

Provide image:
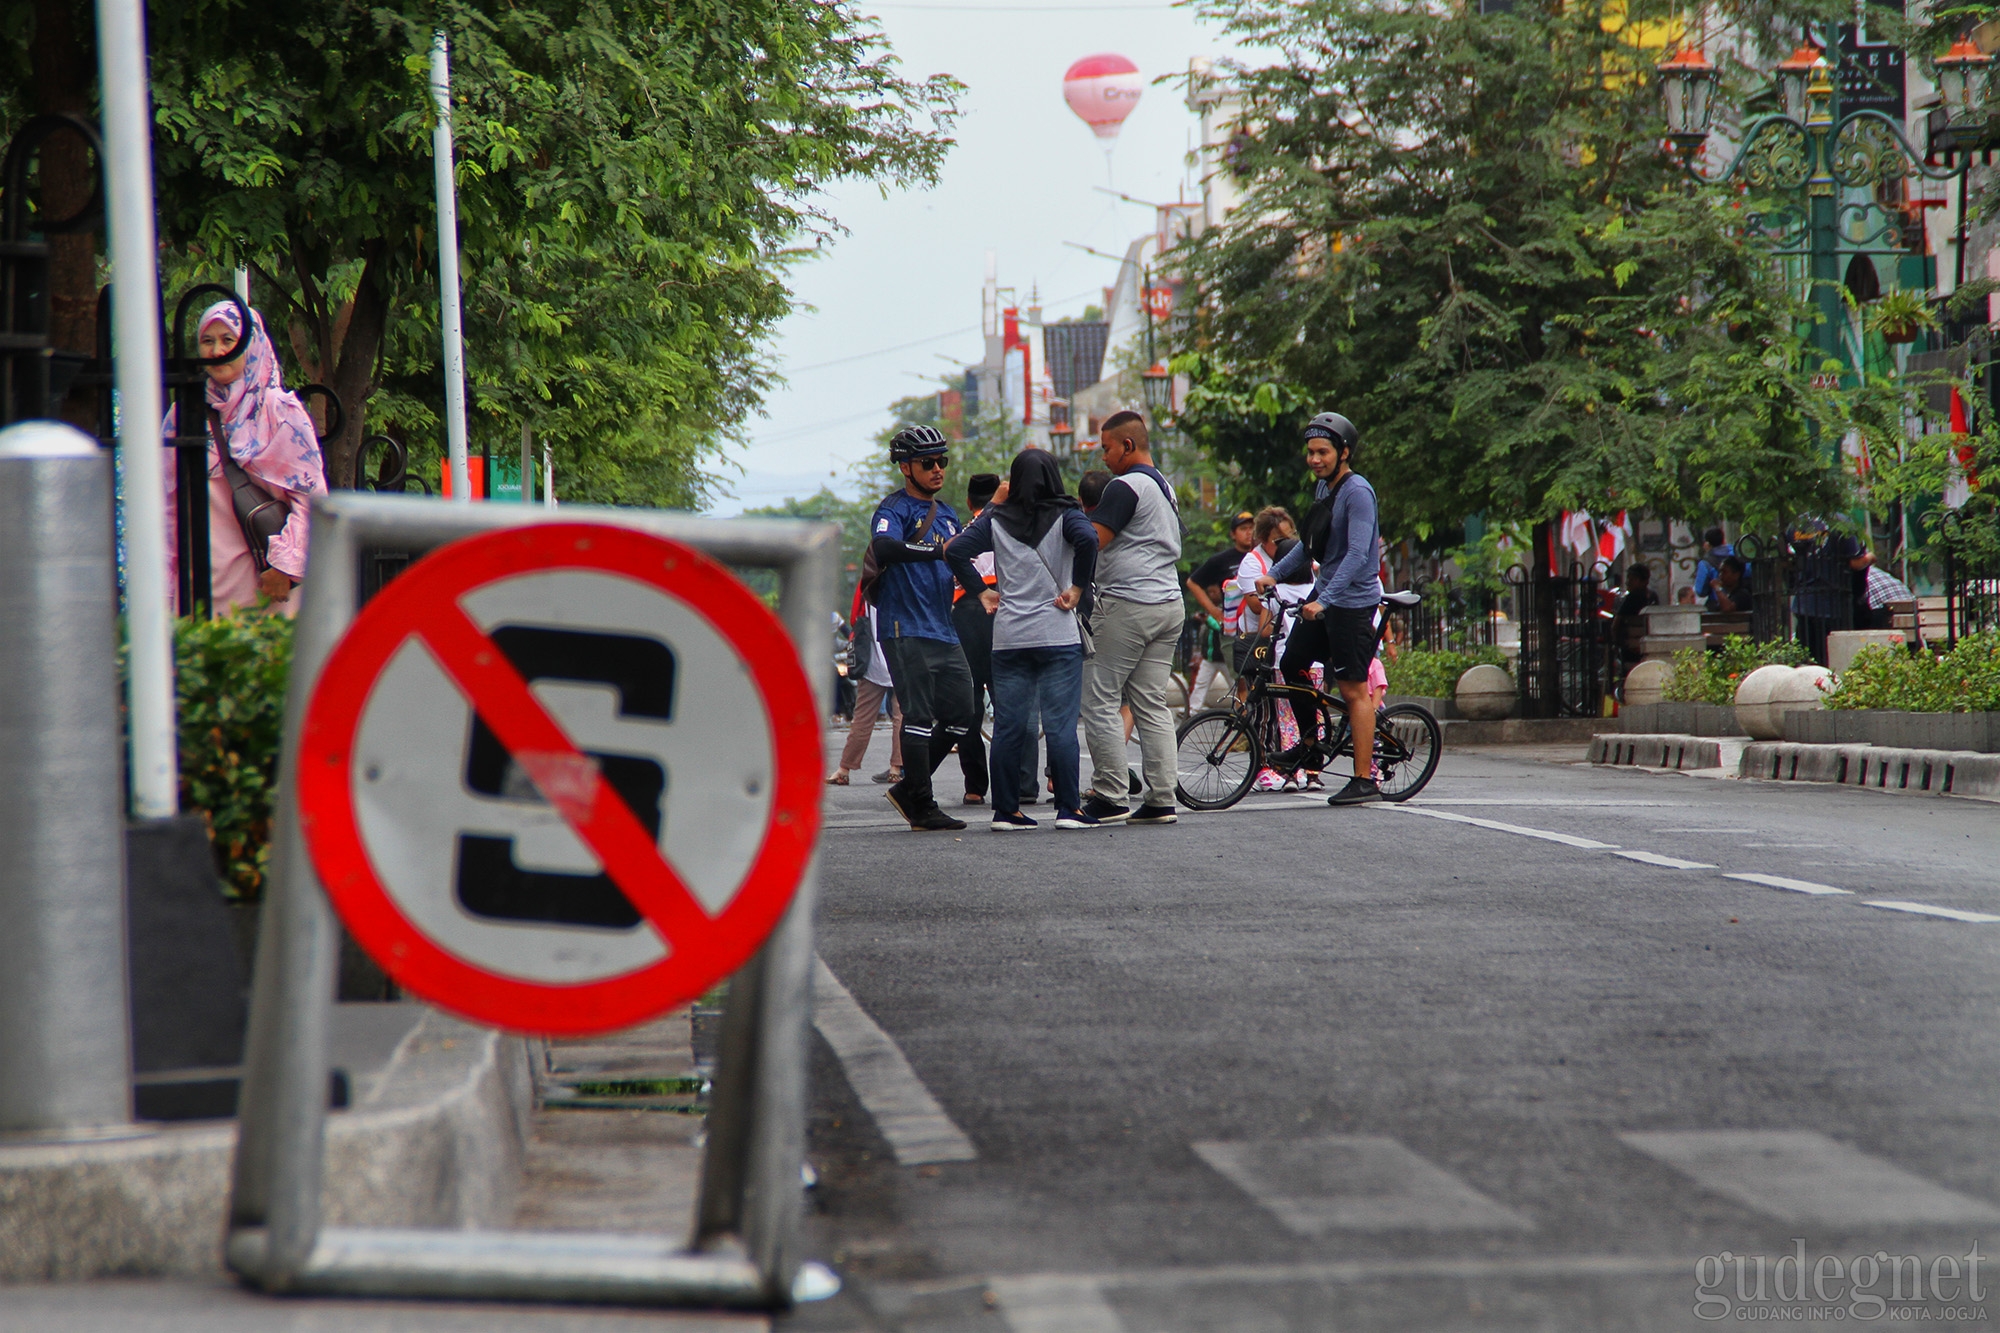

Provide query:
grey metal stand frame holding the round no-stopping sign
left=226, top=492, right=840, bottom=1309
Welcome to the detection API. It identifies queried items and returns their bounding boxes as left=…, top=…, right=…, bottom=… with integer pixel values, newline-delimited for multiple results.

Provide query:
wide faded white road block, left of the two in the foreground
left=1194, top=1135, right=1534, bottom=1237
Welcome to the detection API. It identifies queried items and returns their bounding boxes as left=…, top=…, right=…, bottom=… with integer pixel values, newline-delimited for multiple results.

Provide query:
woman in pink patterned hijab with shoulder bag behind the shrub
left=166, top=300, right=326, bottom=614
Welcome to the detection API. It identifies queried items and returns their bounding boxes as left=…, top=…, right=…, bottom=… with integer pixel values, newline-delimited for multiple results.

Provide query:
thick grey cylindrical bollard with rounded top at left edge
left=0, top=420, right=136, bottom=1139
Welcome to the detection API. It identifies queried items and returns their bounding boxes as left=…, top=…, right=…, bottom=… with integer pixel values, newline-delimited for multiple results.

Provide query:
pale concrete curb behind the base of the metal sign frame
left=0, top=1011, right=534, bottom=1283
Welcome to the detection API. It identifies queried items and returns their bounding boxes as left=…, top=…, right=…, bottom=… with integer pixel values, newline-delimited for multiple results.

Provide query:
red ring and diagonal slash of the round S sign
left=298, top=522, right=820, bottom=1035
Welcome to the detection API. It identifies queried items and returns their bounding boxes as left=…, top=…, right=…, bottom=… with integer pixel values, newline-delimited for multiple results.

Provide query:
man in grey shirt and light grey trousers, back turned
left=1084, top=412, right=1184, bottom=825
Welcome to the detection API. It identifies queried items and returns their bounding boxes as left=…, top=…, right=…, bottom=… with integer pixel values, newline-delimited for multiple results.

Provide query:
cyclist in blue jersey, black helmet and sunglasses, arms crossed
left=868, top=426, right=974, bottom=833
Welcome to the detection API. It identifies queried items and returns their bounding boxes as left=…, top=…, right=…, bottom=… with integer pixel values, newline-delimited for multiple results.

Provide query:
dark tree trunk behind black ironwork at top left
left=28, top=0, right=99, bottom=432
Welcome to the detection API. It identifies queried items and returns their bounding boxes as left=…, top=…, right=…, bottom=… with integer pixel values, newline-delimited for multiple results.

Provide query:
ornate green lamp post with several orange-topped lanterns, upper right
left=1654, top=29, right=1992, bottom=384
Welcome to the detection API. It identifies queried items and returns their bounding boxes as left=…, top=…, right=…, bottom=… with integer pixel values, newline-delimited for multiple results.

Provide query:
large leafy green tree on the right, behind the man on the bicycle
left=1180, top=0, right=1842, bottom=534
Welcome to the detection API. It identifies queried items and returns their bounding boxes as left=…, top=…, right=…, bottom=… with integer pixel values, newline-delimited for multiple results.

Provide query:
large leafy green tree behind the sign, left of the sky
left=0, top=0, right=958, bottom=504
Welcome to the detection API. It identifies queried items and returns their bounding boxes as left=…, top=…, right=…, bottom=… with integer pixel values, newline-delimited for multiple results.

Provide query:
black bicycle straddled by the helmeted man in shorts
left=1174, top=592, right=1444, bottom=811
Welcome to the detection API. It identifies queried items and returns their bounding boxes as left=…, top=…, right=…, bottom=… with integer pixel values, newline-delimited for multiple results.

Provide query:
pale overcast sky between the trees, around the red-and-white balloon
left=714, top=0, right=1226, bottom=514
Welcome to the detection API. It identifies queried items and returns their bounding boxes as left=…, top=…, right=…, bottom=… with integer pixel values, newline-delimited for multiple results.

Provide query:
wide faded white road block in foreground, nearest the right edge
left=1618, top=1129, right=2000, bottom=1227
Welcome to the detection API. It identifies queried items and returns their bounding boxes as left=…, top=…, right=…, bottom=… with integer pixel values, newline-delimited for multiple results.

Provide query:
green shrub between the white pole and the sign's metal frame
left=174, top=612, right=292, bottom=903
